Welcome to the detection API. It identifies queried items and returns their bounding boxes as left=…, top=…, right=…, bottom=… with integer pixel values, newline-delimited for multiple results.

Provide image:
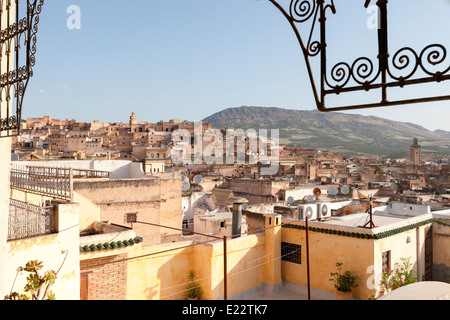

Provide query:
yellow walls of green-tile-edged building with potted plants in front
left=282, top=218, right=430, bottom=300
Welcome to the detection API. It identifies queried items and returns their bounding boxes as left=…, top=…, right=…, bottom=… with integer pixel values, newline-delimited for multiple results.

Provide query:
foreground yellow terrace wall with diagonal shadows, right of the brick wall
left=121, top=235, right=264, bottom=300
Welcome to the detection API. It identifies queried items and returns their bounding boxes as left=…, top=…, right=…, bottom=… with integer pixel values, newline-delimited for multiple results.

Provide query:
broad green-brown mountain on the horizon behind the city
left=203, top=106, right=450, bottom=157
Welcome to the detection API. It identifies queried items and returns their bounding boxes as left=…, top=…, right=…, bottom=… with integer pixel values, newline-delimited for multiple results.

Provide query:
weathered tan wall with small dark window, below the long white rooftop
left=74, top=173, right=182, bottom=245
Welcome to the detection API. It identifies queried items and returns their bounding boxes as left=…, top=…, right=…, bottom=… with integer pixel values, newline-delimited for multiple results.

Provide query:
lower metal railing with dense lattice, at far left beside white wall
left=8, top=199, right=56, bottom=241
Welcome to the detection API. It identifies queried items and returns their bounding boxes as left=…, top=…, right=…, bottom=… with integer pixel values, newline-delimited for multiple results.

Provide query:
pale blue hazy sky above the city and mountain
left=23, top=0, right=450, bottom=131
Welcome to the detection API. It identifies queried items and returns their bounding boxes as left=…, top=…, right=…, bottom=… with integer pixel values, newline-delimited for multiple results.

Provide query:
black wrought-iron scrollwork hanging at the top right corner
left=269, top=0, right=450, bottom=112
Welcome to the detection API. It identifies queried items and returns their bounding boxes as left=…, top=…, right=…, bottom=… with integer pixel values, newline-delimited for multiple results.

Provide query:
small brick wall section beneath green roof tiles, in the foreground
left=80, top=254, right=128, bottom=300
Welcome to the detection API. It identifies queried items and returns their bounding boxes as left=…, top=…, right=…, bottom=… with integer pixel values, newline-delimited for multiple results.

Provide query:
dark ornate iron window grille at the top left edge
left=0, top=0, right=44, bottom=137
